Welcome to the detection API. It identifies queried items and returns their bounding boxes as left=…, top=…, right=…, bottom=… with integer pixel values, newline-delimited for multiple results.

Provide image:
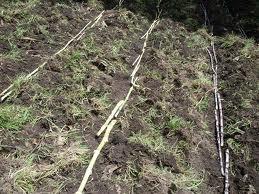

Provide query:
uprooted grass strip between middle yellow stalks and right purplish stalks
left=116, top=19, right=213, bottom=193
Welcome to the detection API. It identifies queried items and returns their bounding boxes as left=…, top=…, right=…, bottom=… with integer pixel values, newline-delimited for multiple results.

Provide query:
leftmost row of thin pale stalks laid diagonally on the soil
left=0, top=11, right=104, bottom=102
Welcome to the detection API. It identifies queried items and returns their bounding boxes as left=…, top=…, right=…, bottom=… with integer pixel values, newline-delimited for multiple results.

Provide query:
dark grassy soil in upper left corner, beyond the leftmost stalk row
left=0, top=1, right=96, bottom=92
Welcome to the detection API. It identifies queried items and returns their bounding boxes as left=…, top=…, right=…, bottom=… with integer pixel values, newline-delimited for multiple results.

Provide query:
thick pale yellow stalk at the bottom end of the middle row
left=76, top=120, right=117, bottom=194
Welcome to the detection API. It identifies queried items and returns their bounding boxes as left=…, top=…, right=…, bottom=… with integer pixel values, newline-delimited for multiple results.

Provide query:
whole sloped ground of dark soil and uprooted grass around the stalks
left=0, top=1, right=258, bottom=193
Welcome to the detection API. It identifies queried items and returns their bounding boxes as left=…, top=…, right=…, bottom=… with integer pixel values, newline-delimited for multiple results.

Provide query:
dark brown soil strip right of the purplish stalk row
left=219, top=42, right=259, bottom=193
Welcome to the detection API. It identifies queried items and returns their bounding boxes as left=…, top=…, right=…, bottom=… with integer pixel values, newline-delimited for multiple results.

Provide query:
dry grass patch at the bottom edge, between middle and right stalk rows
left=114, top=159, right=204, bottom=193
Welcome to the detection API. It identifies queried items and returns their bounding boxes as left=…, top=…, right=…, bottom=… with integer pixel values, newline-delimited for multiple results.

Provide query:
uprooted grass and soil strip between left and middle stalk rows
left=1, top=8, right=152, bottom=193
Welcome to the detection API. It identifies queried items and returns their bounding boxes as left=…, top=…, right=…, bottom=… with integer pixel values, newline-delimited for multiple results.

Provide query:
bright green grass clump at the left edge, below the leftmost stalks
left=0, top=105, right=32, bottom=130
